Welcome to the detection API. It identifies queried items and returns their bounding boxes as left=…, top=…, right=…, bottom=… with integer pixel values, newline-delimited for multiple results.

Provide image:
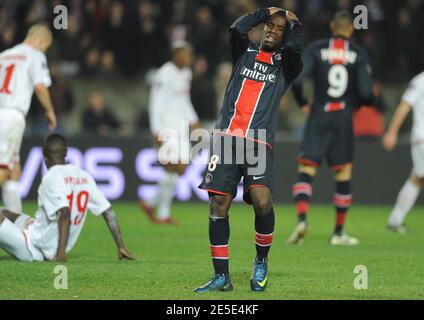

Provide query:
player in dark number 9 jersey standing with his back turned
left=289, top=11, right=374, bottom=245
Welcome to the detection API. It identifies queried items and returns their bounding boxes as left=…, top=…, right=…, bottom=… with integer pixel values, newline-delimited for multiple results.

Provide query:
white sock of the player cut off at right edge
left=388, top=179, right=420, bottom=226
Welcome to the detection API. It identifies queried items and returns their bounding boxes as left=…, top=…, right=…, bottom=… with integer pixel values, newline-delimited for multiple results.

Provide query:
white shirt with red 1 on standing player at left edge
left=0, top=43, right=51, bottom=115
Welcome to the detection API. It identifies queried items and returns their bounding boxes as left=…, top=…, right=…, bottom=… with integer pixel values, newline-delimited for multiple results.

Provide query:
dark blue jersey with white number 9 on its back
left=293, top=37, right=374, bottom=112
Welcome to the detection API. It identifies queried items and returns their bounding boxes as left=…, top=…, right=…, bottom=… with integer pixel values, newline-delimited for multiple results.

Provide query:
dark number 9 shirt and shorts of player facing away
left=293, top=37, right=373, bottom=170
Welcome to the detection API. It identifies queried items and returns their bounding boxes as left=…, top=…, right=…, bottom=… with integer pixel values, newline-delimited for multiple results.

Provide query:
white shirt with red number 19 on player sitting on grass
left=26, top=164, right=111, bottom=260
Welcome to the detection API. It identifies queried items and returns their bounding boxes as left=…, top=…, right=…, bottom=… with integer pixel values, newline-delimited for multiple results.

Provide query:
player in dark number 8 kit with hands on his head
left=195, top=7, right=302, bottom=293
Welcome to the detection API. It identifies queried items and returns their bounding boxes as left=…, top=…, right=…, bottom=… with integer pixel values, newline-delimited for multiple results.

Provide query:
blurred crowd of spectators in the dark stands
left=0, top=0, right=424, bottom=135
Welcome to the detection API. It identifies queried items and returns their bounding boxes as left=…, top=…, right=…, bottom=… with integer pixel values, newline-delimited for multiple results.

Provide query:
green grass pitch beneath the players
left=0, top=202, right=424, bottom=300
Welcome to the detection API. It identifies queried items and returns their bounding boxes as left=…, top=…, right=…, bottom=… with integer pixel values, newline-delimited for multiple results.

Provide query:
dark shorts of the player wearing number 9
left=297, top=110, right=354, bottom=170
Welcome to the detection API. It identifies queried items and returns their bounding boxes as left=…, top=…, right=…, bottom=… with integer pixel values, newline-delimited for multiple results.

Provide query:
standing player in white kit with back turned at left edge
left=0, top=25, right=56, bottom=212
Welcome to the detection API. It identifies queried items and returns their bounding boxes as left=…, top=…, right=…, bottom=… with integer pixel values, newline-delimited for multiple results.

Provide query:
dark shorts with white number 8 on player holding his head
left=199, top=135, right=273, bottom=204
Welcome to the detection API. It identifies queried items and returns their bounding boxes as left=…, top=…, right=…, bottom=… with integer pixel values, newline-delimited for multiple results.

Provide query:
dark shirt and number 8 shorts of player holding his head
left=199, top=9, right=302, bottom=203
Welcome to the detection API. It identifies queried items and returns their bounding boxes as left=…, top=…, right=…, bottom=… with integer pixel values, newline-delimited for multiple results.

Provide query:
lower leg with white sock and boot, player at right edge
left=387, top=173, right=424, bottom=233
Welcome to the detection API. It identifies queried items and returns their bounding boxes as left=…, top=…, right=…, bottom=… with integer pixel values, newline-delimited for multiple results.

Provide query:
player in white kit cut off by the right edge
left=383, top=72, right=424, bottom=233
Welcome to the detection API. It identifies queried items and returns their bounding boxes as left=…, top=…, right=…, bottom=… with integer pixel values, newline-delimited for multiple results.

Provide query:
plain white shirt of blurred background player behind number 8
left=149, top=62, right=199, bottom=134
